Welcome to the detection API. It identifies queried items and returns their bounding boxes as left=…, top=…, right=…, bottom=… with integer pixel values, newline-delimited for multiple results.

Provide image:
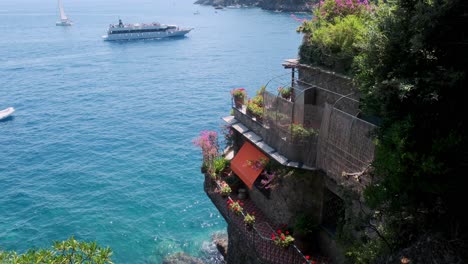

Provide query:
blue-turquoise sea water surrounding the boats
left=0, top=0, right=301, bottom=263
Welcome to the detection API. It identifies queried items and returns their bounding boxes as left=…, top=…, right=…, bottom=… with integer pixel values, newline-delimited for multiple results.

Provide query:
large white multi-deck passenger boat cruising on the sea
left=102, top=19, right=193, bottom=40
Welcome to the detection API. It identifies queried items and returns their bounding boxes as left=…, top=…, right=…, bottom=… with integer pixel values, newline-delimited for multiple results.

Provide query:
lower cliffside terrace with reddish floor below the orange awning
left=204, top=174, right=330, bottom=264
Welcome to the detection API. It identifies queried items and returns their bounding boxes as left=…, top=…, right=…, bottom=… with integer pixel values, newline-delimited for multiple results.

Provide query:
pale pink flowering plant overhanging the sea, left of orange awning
left=193, top=130, right=221, bottom=174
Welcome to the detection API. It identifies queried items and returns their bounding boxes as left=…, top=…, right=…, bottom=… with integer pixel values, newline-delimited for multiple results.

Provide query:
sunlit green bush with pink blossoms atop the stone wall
left=297, top=0, right=374, bottom=73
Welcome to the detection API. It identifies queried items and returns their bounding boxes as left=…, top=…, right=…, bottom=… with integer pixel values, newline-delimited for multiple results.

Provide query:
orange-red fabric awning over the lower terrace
left=231, top=141, right=269, bottom=189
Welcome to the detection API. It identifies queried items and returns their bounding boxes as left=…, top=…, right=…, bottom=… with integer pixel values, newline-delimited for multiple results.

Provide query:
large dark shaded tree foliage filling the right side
left=354, top=0, right=468, bottom=258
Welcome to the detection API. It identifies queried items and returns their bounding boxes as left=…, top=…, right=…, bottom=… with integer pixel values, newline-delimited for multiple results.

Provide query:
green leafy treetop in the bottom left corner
left=0, top=237, right=112, bottom=264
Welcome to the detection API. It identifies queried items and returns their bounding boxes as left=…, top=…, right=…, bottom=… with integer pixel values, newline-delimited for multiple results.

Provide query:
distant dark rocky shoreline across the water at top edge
left=195, top=0, right=311, bottom=12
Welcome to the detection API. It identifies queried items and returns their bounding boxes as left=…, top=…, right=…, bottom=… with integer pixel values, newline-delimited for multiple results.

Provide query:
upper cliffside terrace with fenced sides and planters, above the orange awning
left=229, top=65, right=376, bottom=191
